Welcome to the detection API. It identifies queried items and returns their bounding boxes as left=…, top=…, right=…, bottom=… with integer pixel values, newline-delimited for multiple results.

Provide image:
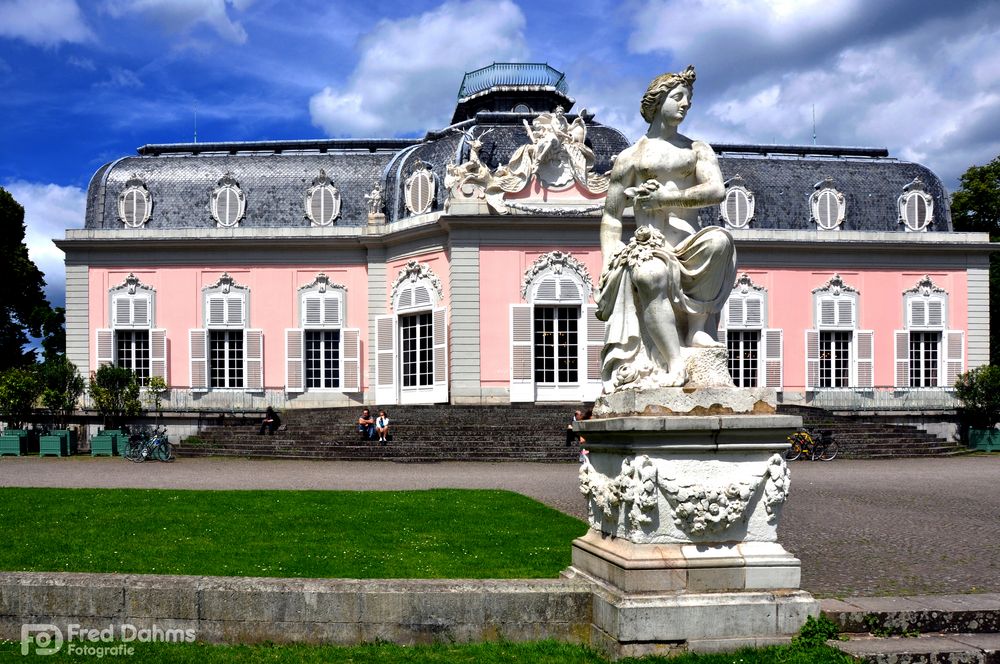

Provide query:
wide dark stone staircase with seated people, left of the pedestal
left=177, top=404, right=581, bottom=462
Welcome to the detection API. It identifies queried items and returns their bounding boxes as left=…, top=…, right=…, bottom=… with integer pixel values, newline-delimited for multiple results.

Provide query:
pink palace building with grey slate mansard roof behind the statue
left=57, top=64, right=992, bottom=412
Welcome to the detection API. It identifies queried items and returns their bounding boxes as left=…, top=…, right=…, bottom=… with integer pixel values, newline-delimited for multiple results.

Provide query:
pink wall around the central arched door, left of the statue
left=479, top=246, right=601, bottom=387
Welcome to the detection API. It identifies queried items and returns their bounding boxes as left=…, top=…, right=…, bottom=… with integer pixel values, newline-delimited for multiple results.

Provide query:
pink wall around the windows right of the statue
left=752, top=267, right=968, bottom=390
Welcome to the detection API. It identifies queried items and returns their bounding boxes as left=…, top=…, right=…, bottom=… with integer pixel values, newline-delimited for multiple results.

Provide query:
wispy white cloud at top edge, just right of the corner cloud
left=104, top=0, right=253, bottom=44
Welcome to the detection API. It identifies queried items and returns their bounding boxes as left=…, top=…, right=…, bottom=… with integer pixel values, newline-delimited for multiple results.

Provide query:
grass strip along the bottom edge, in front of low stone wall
left=0, top=641, right=854, bottom=664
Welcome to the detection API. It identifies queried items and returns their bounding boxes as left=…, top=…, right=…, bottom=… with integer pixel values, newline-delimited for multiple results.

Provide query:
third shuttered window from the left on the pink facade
left=285, top=273, right=361, bottom=393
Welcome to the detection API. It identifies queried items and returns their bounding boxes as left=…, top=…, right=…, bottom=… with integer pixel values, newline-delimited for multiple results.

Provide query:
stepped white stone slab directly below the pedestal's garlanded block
left=566, top=530, right=801, bottom=593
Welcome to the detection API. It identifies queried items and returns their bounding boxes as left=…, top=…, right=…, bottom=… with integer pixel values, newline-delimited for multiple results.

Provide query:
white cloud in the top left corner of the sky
left=0, top=0, right=94, bottom=47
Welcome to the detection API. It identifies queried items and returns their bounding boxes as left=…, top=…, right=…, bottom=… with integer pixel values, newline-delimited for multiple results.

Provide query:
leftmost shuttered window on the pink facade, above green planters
left=96, top=274, right=167, bottom=385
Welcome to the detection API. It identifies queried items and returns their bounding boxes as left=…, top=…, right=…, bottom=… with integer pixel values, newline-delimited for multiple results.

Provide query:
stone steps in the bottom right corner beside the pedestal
left=820, top=594, right=1000, bottom=664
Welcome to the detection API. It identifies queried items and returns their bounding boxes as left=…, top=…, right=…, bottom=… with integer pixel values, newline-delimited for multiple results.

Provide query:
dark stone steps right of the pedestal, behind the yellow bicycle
left=778, top=405, right=967, bottom=459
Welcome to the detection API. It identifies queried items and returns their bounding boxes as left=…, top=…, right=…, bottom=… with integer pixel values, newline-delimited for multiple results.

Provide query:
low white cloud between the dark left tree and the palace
left=4, top=180, right=87, bottom=307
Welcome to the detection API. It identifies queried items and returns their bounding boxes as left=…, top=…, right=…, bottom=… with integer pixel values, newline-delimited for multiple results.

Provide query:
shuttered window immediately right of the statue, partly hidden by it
left=719, top=273, right=783, bottom=389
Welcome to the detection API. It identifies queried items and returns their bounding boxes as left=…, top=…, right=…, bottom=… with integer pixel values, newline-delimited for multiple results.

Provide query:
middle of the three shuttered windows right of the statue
left=806, top=274, right=875, bottom=390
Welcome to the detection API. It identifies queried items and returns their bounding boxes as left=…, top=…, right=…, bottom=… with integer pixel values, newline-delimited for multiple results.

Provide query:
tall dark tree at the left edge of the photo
left=0, top=187, right=51, bottom=371
